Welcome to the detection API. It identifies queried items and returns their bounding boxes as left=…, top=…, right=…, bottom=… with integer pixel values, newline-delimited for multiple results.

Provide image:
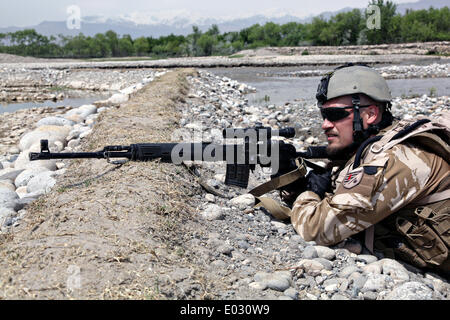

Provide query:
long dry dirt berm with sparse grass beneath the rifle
left=0, top=69, right=232, bottom=299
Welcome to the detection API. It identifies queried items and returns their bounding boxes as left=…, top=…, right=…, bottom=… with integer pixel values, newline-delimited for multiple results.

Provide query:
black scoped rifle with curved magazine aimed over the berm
left=29, top=125, right=327, bottom=188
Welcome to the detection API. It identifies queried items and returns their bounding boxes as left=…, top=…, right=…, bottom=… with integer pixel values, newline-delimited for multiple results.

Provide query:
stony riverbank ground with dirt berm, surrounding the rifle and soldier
left=0, top=60, right=450, bottom=300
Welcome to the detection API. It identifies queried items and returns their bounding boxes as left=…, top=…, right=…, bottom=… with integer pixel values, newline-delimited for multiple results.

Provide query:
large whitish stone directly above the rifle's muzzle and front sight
left=19, top=125, right=71, bottom=151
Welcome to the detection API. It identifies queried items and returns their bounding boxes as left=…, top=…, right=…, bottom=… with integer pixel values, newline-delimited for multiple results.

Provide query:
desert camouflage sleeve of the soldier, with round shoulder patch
left=290, top=144, right=450, bottom=245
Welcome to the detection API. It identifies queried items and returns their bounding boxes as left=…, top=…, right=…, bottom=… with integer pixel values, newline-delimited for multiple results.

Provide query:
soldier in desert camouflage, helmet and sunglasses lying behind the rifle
left=288, top=64, right=450, bottom=272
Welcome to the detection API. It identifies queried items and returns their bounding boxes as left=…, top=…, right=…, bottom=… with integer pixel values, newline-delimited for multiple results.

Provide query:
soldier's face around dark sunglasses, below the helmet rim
left=322, top=97, right=353, bottom=153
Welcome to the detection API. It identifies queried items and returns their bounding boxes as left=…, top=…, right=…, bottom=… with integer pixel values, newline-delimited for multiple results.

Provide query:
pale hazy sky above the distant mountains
left=0, top=0, right=418, bottom=27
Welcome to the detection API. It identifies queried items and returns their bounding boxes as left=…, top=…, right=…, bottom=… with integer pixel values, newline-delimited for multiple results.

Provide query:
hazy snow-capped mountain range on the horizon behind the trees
left=0, top=0, right=448, bottom=38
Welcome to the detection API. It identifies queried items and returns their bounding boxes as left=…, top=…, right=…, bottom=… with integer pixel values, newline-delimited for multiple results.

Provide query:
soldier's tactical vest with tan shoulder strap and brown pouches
left=362, top=111, right=450, bottom=273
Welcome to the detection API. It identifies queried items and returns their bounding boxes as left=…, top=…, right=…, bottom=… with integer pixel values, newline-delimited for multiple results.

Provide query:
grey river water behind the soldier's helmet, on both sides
left=204, top=67, right=450, bottom=105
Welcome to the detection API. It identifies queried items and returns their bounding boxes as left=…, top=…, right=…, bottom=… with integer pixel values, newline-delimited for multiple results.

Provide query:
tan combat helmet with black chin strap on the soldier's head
left=316, top=63, right=392, bottom=141
